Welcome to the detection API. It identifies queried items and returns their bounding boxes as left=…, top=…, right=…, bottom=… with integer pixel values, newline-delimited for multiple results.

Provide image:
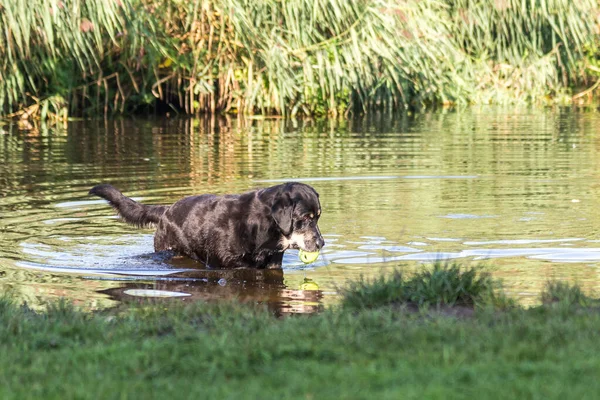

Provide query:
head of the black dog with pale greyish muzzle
left=271, top=182, right=325, bottom=252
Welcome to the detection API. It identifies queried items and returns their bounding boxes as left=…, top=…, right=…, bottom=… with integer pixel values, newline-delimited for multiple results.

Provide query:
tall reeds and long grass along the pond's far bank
left=0, top=0, right=600, bottom=119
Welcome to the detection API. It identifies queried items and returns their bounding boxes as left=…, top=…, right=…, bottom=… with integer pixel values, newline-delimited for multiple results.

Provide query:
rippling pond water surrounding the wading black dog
left=0, top=107, right=600, bottom=314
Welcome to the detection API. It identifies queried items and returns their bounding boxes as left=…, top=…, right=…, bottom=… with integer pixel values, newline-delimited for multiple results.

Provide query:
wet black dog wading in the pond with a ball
left=90, top=182, right=325, bottom=268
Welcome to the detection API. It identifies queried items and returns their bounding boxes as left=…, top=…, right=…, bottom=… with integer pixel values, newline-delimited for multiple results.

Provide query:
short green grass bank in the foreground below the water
left=0, top=268, right=600, bottom=399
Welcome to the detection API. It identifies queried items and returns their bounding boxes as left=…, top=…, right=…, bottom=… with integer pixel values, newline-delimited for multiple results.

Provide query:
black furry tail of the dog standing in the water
left=90, top=184, right=169, bottom=227
